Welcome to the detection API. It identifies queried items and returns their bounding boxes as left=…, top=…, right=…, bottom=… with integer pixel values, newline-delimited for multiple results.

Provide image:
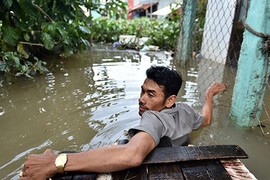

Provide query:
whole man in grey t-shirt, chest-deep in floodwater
left=20, top=66, right=226, bottom=179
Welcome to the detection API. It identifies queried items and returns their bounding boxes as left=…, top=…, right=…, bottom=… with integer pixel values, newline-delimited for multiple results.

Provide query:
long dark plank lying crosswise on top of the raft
left=143, top=145, right=248, bottom=164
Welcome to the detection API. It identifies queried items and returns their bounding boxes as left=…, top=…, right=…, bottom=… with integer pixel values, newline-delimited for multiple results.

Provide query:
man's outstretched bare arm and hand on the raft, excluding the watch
left=21, top=132, right=156, bottom=179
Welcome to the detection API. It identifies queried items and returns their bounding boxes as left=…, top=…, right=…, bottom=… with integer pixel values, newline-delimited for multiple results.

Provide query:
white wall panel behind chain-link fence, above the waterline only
left=201, top=0, right=236, bottom=64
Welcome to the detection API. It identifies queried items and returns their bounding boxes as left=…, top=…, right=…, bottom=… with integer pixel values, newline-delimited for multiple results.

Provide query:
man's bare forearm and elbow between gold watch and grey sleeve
left=65, top=132, right=156, bottom=172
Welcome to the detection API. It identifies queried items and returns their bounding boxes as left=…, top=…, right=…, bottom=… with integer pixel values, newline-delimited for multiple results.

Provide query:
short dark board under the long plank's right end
left=179, top=160, right=231, bottom=180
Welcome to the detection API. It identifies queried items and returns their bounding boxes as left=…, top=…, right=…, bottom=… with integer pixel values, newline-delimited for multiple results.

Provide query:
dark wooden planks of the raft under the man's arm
left=52, top=145, right=248, bottom=180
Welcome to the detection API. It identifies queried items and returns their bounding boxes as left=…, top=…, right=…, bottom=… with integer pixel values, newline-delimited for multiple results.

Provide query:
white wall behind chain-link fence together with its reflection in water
left=197, top=0, right=236, bottom=99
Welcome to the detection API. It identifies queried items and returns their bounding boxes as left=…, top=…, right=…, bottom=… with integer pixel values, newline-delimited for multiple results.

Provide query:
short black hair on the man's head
left=146, top=66, right=182, bottom=100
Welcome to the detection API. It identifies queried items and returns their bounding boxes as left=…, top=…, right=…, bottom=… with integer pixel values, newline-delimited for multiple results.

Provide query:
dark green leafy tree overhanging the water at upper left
left=0, top=0, right=124, bottom=77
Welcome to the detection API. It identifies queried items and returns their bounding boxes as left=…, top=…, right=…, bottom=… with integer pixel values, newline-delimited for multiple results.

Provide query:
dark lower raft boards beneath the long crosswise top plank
left=113, top=160, right=231, bottom=180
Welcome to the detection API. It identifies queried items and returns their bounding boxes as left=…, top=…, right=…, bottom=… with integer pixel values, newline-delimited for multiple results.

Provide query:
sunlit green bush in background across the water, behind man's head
left=92, top=18, right=179, bottom=50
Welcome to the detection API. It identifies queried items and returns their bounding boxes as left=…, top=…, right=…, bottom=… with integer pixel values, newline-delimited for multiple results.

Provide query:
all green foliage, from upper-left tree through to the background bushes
left=0, top=0, right=185, bottom=77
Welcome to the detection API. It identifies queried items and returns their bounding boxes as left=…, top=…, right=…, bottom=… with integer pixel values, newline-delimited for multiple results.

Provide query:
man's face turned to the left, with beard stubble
left=139, top=78, right=166, bottom=115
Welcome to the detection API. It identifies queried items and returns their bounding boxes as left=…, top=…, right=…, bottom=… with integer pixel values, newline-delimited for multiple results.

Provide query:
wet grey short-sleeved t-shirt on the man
left=128, top=102, right=203, bottom=146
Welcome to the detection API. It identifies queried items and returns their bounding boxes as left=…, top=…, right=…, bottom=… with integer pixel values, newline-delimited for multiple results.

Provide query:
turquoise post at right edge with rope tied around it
left=230, top=0, right=270, bottom=126
